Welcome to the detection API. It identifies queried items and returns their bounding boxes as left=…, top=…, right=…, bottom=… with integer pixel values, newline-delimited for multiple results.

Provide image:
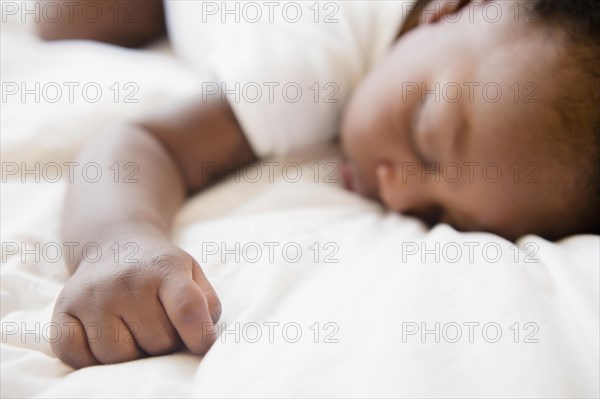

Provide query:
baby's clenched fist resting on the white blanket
left=52, top=238, right=221, bottom=368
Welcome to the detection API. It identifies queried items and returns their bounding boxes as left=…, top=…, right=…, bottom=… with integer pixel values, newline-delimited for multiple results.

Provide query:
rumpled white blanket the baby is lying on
left=1, top=10, right=600, bottom=397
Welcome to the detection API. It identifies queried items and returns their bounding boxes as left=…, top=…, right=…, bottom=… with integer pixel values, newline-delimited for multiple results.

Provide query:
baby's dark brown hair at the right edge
left=527, top=0, right=600, bottom=233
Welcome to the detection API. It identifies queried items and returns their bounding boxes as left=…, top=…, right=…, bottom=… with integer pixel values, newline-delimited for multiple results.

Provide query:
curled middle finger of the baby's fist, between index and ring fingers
left=123, top=296, right=182, bottom=356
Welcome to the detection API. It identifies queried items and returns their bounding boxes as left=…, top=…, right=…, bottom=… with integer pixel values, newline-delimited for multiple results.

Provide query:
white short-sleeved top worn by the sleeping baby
left=165, top=0, right=414, bottom=158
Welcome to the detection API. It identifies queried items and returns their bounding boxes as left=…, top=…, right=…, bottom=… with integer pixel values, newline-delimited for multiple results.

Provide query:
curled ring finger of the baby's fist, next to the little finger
left=82, top=314, right=146, bottom=364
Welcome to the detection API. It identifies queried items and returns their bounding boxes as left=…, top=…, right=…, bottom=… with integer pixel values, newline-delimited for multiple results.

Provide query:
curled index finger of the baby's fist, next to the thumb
left=158, top=272, right=215, bottom=355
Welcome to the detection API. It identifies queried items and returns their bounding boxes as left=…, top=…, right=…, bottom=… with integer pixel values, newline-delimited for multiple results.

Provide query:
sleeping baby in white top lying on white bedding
left=39, top=0, right=600, bottom=368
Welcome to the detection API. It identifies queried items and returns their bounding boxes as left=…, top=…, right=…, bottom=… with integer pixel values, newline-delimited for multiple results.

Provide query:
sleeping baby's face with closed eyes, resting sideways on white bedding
left=341, top=1, right=575, bottom=239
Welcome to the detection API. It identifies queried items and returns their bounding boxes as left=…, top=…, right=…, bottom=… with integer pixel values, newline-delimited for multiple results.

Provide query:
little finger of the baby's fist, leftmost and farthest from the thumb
left=50, top=312, right=100, bottom=369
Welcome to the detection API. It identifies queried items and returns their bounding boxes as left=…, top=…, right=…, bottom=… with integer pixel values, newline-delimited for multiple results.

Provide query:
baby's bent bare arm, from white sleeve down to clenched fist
left=53, top=99, right=255, bottom=367
